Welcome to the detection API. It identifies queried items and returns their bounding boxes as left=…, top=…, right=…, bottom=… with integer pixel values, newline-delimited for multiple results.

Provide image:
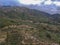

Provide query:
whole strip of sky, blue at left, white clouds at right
left=0, top=0, right=60, bottom=6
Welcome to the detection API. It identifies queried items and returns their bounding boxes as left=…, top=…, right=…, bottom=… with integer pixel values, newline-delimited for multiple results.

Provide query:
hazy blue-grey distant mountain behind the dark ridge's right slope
left=24, top=4, right=60, bottom=14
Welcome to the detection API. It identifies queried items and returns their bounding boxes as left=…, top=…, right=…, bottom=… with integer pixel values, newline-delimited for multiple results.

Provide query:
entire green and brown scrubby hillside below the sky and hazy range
left=0, top=6, right=60, bottom=45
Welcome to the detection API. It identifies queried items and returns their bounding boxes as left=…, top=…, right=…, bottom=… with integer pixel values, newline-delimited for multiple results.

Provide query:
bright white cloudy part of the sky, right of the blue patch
left=18, top=0, right=60, bottom=6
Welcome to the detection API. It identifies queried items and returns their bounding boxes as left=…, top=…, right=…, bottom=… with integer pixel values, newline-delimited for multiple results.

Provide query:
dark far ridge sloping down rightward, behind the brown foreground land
left=0, top=6, right=55, bottom=23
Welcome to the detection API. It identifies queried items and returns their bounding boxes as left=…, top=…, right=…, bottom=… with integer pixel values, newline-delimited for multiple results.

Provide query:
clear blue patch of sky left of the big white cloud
left=0, top=0, right=20, bottom=6
